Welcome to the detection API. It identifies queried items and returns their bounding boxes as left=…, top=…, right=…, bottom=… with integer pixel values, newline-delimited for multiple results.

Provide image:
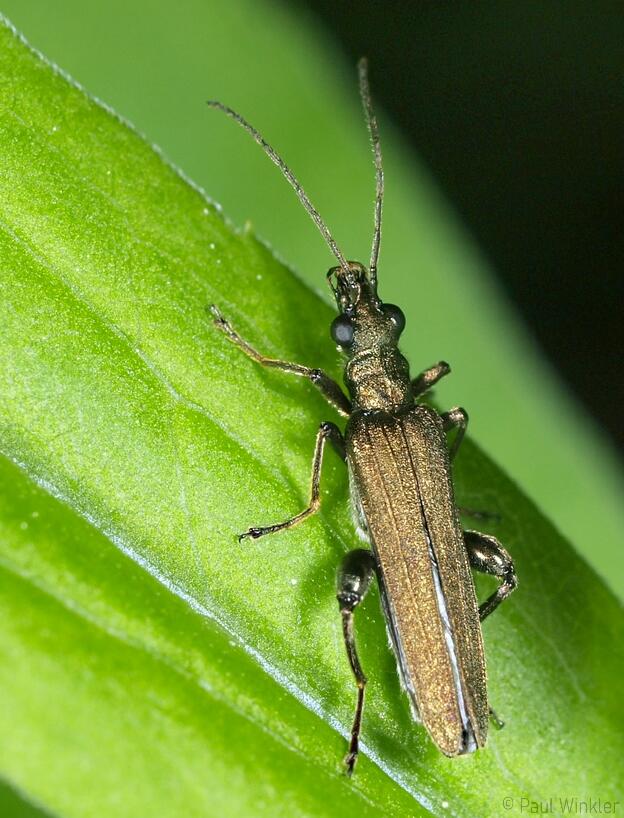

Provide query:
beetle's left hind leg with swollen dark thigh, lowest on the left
left=336, top=548, right=376, bottom=775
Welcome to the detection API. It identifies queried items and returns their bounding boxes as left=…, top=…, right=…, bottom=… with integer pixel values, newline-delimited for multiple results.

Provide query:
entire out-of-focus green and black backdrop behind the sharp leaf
left=2, top=0, right=624, bottom=593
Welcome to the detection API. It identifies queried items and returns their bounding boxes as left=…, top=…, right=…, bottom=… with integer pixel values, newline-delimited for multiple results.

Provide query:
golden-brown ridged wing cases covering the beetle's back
left=346, top=405, right=488, bottom=756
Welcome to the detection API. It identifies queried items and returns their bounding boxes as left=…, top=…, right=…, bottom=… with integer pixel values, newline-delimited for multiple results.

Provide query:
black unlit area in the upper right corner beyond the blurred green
left=300, top=0, right=624, bottom=453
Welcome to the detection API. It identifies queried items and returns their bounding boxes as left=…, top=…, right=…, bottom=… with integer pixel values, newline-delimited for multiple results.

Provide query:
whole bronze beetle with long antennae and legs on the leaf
left=208, top=60, right=517, bottom=775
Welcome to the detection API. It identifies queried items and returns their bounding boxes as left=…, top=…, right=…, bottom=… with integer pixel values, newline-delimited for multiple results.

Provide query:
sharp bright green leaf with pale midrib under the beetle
left=0, top=15, right=624, bottom=818
